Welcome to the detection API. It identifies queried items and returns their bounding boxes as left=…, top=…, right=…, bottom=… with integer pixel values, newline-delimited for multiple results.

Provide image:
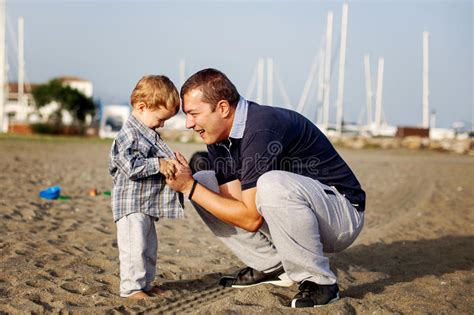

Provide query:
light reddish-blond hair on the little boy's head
left=130, top=75, right=179, bottom=110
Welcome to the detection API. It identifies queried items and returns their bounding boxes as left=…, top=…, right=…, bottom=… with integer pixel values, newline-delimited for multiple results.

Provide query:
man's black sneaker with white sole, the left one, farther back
left=219, top=267, right=293, bottom=288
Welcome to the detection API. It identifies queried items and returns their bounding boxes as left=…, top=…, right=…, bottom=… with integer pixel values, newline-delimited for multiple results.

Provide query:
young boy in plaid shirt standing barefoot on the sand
left=109, top=75, right=183, bottom=299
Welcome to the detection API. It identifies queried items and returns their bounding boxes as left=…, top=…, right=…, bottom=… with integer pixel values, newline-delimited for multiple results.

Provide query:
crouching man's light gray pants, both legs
left=193, top=171, right=364, bottom=284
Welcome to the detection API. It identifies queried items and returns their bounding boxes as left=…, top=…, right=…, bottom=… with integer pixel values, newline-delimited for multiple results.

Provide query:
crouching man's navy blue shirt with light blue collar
left=207, top=98, right=365, bottom=211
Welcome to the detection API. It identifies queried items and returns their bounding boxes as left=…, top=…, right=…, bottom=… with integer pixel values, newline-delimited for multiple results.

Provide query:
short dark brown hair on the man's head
left=180, top=68, right=240, bottom=111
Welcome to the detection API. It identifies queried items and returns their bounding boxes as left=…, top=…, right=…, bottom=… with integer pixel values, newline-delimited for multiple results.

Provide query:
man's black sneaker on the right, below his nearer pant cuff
left=291, top=281, right=339, bottom=308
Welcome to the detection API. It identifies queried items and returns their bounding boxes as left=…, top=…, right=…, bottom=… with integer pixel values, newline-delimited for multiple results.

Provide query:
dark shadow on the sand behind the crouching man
left=331, top=236, right=474, bottom=298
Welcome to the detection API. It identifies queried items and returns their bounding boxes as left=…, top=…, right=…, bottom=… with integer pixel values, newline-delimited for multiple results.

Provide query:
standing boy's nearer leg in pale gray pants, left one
left=117, top=213, right=154, bottom=297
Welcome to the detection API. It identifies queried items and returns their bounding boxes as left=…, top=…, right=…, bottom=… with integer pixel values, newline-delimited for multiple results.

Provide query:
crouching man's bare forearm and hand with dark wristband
left=167, top=153, right=263, bottom=232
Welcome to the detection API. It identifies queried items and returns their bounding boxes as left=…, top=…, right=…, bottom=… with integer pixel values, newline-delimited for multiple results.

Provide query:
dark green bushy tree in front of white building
left=32, top=79, right=96, bottom=126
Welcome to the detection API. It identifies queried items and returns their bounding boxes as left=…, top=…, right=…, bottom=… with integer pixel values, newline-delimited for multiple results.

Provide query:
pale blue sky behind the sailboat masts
left=7, top=0, right=474, bottom=127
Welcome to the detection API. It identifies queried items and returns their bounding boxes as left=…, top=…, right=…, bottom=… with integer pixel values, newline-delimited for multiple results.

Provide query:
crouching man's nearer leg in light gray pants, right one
left=256, top=171, right=364, bottom=285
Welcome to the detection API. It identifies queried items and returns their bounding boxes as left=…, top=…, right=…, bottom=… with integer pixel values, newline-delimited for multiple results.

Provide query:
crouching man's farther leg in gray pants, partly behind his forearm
left=193, top=171, right=281, bottom=271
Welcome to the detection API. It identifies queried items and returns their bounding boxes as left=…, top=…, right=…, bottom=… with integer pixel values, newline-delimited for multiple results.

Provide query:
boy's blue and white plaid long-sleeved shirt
left=109, top=115, right=184, bottom=221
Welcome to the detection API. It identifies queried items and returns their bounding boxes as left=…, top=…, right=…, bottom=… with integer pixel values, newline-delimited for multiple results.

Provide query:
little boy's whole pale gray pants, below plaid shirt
left=117, top=213, right=158, bottom=297
